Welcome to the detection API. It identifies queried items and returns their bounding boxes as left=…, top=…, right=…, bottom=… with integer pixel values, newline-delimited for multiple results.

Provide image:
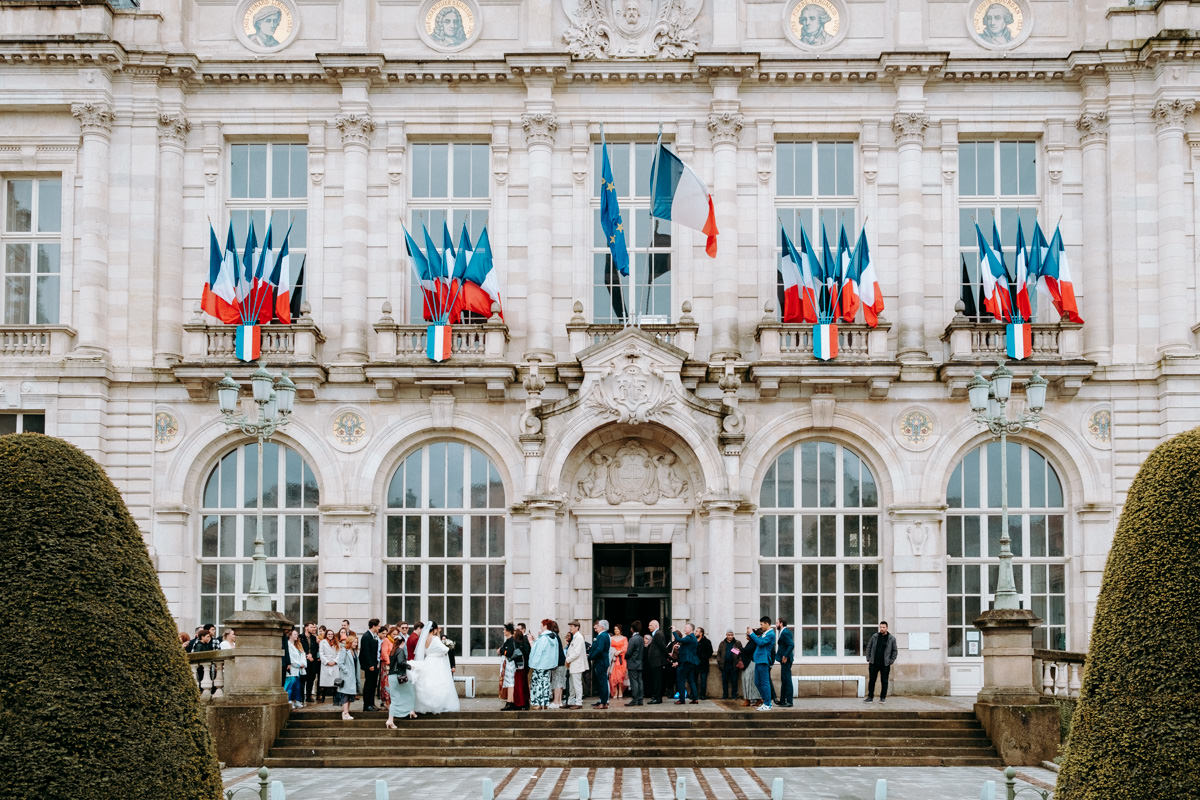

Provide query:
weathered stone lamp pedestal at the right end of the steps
left=974, top=608, right=1058, bottom=766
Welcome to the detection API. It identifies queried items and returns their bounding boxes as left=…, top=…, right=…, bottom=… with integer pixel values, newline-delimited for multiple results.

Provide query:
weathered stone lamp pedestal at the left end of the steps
left=204, top=610, right=292, bottom=766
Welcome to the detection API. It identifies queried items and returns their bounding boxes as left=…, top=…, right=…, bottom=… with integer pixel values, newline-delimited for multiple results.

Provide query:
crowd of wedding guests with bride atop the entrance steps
left=180, top=616, right=898, bottom=728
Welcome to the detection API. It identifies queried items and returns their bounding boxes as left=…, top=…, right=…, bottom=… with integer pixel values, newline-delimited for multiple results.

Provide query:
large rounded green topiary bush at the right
left=1055, top=428, right=1200, bottom=800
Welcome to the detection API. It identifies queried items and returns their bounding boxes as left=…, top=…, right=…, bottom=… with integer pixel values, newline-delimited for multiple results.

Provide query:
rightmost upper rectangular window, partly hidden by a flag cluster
left=954, top=142, right=1042, bottom=320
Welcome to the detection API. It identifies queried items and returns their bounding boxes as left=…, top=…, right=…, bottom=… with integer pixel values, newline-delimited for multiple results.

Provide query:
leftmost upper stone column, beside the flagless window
left=71, top=102, right=113, bottom=359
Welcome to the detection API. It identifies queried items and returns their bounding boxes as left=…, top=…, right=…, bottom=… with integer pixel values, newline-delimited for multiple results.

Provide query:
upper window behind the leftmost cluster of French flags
left=226, top=142, right=310, bottom=317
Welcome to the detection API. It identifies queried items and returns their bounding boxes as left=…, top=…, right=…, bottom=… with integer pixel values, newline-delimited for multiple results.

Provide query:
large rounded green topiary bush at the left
left=0, top=433, right=221, bottom=800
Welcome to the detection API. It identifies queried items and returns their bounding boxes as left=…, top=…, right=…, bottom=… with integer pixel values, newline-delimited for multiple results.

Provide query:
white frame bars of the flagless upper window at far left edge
left=0, top=172, right=67, bottom=326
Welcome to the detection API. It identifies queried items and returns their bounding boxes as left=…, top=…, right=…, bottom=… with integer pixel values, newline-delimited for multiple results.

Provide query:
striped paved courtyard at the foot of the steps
left=223, top=766, right=1055, bottom=800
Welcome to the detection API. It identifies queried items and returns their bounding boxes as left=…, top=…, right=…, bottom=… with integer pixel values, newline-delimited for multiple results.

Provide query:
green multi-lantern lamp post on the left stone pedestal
left=217, top=361, right=296, bottom=612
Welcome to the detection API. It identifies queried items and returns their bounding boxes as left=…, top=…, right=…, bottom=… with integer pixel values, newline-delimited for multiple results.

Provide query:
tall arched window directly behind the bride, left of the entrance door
left=386, top=441, right=505, bottom=656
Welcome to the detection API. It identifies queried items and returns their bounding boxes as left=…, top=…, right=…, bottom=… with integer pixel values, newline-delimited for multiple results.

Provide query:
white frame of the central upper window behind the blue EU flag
left=588, top=137, right=678, bottom=325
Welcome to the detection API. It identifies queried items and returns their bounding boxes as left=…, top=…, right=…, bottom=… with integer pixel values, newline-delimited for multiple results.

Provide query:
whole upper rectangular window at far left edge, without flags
left=0, top=176, right=62, bottom=325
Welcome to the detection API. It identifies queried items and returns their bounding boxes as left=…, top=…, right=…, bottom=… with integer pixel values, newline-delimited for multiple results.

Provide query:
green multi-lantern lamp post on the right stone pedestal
left=967, top=362, right=1046, bottom=608
